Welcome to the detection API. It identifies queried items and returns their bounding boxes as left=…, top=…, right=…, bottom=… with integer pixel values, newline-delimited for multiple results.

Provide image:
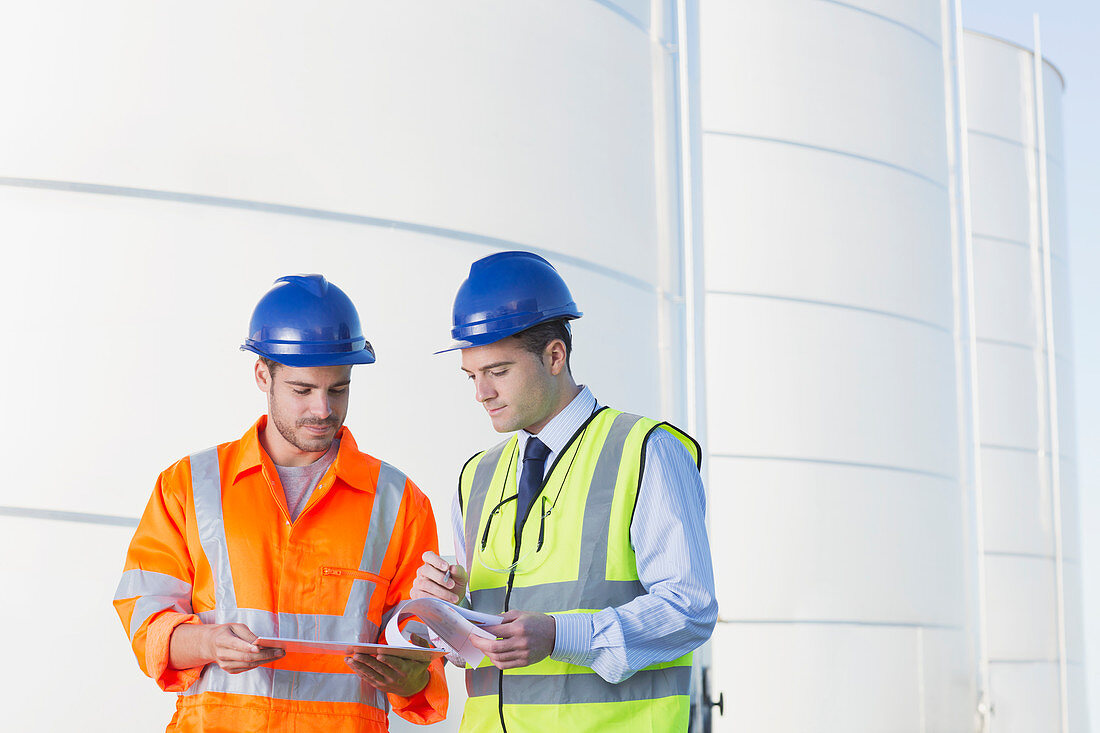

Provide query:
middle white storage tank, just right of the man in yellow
left=700, top=0, right=976, bottom=732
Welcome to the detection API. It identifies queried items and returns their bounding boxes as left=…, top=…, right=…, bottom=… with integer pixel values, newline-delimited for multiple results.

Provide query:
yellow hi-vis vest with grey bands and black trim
left=459, top=407, right=701, bottom=733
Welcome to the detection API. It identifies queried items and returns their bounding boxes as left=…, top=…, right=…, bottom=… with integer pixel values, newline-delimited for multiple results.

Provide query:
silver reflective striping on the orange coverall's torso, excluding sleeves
left=183, top=448, right=406, bottom=710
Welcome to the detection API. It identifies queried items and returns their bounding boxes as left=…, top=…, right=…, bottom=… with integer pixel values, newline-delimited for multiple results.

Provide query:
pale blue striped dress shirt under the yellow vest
left=451, top=387, right=718, bottom=682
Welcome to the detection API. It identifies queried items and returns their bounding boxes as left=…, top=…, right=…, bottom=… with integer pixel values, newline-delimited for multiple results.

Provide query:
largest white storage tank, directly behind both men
left=0, top=0, right=684, bottom=731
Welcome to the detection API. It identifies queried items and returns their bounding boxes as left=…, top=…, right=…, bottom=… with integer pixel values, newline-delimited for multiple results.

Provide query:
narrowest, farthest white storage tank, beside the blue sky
left=965, top=32, right=1088, bottom=731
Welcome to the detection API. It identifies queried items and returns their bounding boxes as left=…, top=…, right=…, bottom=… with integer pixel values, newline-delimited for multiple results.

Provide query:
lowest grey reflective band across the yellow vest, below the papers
left=503, top=665, right=691, bottom=705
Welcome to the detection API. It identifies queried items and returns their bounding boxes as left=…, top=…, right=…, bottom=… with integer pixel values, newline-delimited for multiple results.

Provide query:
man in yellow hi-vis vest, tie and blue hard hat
left=413, top=252, right=717, bottom=733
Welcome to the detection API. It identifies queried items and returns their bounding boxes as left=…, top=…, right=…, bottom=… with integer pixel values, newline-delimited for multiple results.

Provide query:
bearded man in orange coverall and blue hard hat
left=114, top=275, right=448, bottom=733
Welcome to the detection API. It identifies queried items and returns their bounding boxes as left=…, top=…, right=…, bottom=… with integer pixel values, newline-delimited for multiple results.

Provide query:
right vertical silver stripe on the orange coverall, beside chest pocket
left=341, top=461, right=406, bottom=629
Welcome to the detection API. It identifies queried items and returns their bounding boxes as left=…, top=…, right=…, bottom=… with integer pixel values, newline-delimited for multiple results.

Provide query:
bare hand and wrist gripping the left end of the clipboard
left=168, top=624, right=286, bottom=675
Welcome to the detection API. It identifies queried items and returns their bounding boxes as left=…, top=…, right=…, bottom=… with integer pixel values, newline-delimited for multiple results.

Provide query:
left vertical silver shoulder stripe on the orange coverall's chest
left=190, top=448, right=237, bottom=624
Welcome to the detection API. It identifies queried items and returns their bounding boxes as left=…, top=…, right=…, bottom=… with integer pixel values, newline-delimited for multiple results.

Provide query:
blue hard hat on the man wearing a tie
left=436, top=252, right=582, bottom=353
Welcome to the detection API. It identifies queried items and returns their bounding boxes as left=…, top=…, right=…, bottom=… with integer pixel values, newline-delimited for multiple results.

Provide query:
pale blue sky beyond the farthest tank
left=963, top=0, right=1100, bottom=717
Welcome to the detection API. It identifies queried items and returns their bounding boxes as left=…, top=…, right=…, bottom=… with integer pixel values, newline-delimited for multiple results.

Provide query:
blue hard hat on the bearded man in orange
left=241, top=275, right=374, bottom=367
